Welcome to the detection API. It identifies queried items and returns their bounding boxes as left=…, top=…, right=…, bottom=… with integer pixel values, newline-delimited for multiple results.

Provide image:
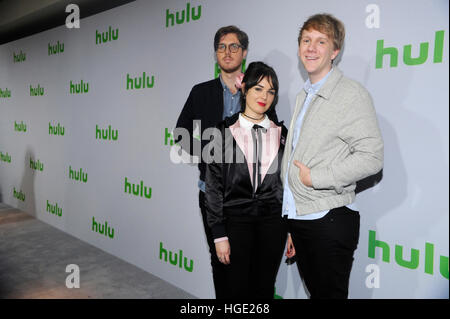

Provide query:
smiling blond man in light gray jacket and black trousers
left=281, top=14, right=383, bottom=298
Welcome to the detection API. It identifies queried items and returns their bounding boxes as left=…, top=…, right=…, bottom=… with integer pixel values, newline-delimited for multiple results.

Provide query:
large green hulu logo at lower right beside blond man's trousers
left=369, top=230, right=449, bottom=279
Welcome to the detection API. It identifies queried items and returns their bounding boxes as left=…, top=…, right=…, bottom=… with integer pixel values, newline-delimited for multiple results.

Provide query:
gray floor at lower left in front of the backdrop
left=0, top=203, right=195, bottom=299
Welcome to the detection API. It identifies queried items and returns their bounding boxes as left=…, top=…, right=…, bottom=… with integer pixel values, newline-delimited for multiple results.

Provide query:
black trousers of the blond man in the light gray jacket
left=289, top=206, right=360, bottom=299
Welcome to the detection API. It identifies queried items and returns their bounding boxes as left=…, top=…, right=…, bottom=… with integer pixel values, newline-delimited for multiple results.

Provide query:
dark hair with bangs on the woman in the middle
left=241, top=61, right=278, bottom=114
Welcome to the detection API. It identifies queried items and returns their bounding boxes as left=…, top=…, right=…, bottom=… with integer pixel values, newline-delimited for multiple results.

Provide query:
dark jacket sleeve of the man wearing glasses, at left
left=173, top=87, right=201, bottom=155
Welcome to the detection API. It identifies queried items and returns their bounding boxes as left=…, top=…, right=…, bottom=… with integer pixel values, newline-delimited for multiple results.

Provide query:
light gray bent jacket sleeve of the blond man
left=311, top=87, right=384, bottom=193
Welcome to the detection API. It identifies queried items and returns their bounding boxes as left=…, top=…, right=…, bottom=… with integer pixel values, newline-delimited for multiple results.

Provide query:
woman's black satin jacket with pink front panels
left=205, top=113, right=287, bottom=239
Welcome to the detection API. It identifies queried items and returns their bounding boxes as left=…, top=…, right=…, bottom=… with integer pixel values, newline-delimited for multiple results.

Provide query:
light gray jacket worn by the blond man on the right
left=281, top=66, right=383, bottom=215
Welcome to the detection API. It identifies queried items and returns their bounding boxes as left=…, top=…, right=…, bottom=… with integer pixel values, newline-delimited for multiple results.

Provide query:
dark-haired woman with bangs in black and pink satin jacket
left=205, top=62, right=287, bottom=299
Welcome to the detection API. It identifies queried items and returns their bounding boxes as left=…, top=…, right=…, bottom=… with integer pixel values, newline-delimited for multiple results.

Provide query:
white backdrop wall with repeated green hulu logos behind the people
left=0, top=0, right=449, bottom=298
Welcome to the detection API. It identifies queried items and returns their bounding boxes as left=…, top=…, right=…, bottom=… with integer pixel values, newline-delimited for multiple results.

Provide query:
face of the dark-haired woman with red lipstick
left=245, top=77, right=276, bottom=118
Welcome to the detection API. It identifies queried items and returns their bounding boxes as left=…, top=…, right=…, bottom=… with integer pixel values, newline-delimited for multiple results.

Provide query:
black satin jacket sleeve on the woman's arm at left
left=205, top=127, right=226, bottom=239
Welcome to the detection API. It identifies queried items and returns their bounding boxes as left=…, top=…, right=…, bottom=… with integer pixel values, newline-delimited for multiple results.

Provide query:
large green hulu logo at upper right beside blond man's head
left=375, top=30, right=445, bottom=69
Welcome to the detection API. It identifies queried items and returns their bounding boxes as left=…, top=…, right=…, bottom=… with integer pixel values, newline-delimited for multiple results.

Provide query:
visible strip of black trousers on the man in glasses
left=199, top=191, right=228, bottom=299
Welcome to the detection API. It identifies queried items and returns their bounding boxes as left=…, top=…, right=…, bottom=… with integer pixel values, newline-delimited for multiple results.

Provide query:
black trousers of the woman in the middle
left=227, top=212, right=287, bottom=299
